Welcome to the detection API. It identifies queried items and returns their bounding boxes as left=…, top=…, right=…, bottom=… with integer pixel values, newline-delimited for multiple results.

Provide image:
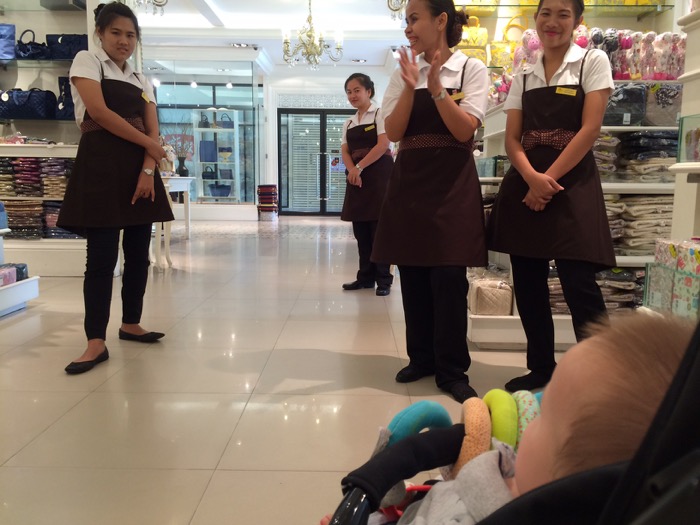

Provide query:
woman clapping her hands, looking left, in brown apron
left=372, top=0, right=488, bottom=403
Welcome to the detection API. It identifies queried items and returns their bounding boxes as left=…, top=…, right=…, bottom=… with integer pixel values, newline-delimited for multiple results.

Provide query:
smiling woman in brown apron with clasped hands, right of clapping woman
left=487, top=0, right=615, bottom=392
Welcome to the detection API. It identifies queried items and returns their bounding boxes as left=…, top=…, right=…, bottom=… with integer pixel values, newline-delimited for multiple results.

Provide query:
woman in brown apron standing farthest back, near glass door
left=340, top=73, right=394, bottom=296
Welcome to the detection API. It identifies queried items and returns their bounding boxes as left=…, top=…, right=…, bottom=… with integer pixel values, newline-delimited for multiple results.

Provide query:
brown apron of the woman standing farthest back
left=340, top=110, right=394, bottom=222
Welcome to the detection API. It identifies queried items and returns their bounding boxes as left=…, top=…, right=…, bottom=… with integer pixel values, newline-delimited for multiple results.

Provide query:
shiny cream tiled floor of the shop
left=0, top=218, right=525, bottom=525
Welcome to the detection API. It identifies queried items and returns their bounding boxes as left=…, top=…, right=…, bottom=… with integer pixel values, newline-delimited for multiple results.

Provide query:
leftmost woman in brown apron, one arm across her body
left=58, top=2, right=173, bottom=374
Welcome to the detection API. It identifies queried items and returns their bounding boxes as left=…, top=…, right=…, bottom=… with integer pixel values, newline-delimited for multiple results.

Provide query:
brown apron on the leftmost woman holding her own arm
left=58, top=69, right=174, bottom=235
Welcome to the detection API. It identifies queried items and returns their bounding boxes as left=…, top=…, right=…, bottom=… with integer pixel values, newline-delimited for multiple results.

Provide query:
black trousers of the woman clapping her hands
left=399, top=266, right=471, bottom=389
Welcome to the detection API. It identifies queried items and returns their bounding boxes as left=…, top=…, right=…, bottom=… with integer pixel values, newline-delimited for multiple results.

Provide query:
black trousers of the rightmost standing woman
left=510, top=255, right=607, bottom=372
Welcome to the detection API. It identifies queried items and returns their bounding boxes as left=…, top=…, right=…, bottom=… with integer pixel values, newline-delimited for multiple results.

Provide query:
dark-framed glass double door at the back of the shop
left=277, top=109, right=354, bottom=215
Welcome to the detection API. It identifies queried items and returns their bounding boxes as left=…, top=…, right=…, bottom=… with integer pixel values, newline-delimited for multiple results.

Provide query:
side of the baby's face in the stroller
left=514, top=339, right=595, bottom=496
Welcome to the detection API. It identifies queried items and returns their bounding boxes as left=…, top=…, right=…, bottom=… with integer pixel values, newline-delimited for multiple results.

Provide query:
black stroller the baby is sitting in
left=330, top=324, right=700, bottom=525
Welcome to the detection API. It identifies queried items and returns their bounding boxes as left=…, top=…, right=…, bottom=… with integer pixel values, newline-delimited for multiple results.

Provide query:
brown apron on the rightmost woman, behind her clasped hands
left=487, top=52, right=615, bottom=267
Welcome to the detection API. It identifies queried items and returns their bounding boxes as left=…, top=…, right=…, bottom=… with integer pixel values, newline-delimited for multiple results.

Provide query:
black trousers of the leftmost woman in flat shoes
left=83, top=224, right=151, bottom=340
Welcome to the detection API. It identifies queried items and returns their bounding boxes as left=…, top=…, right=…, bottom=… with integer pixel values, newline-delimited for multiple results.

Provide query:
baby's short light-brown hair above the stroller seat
left=552, top=313, right=695, bottom=479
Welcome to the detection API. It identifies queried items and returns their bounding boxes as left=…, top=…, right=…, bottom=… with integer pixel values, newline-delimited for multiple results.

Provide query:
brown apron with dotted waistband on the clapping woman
left=372, top=64, right=486, bottom=266
